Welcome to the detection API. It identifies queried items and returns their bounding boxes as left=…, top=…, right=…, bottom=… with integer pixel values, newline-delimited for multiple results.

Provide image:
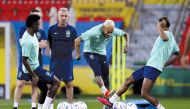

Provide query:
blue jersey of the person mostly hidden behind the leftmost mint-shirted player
left=18, top=26, right=47, bottom=65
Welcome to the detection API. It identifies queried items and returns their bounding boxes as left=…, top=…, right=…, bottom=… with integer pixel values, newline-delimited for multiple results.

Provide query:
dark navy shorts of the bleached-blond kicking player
left=84, top=52, right=109, bottom=76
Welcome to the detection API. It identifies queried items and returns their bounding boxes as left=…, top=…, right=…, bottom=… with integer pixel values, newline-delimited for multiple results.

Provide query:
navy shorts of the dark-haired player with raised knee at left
left=34, top=66, right=54, bottom=84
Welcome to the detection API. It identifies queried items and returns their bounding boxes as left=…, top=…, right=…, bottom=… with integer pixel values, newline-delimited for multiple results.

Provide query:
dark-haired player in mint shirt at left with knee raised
left=21, top=15, right=60, bottom=109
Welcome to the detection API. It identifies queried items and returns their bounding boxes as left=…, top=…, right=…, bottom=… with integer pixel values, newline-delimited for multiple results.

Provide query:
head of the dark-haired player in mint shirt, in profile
left=26, top=15, right=40, bottom=32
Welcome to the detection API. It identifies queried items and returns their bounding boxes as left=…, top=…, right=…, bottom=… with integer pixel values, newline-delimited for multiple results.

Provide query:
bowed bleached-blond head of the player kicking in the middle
left=102, top=20, right=115, bottom=38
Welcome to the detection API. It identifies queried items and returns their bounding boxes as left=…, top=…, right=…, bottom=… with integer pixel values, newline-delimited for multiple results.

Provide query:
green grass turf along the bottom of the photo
left=0, top=97, right=190, bottom=109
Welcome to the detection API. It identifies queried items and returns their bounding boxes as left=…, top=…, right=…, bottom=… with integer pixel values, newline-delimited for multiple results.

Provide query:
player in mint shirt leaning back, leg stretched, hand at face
left=97, top=17, right=180, bottom=109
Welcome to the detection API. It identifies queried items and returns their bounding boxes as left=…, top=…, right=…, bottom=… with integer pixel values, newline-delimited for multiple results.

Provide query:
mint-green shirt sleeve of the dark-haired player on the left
left=21, top=42, right=32, bottom=57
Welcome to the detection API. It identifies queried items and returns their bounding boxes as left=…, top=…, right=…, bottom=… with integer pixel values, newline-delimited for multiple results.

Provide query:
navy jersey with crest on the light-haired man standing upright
left=48, top=24, right=77, bottom=61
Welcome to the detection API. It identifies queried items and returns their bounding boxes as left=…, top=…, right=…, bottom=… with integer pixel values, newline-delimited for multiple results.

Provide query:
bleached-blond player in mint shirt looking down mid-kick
left=75, top=20, right=129, bottom=98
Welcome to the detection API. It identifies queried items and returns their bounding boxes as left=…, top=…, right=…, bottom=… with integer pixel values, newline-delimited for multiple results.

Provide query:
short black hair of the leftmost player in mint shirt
left=26, top=15, right=40, bottom=28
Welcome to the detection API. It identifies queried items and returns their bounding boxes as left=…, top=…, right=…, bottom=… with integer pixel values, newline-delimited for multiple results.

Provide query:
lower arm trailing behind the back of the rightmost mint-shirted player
left=164, top=52, right=181, bottom=67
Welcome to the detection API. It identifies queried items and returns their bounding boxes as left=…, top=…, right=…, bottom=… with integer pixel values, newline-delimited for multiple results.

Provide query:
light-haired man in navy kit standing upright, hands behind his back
left=48, top=8, right=77, bottom=103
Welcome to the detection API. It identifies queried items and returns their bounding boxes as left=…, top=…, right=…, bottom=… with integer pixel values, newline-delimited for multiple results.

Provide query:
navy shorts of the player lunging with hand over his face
left=132, top=66, right=161, bottom=82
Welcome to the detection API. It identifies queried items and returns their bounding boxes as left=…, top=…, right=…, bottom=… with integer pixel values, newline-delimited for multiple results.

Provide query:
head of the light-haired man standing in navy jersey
left=58, top=8, right=69, bottom=25
